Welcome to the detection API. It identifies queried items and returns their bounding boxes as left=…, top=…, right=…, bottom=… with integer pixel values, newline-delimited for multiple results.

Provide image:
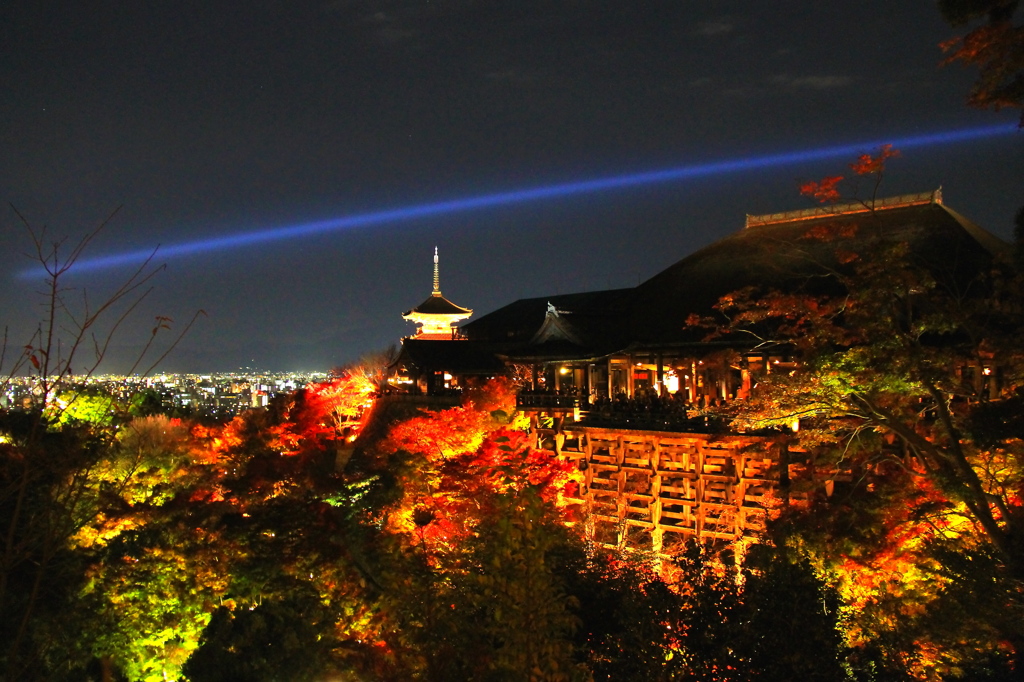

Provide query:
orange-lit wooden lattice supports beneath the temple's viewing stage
left=537, top=427, right=804, bottom=554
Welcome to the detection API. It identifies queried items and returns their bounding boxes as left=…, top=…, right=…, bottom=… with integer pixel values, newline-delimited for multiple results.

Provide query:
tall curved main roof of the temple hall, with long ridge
left=629, top=199, right=1008, bottom=343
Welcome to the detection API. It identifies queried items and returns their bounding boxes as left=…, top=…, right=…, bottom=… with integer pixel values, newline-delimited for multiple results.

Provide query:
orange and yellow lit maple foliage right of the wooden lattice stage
left=691, top=148, right=1024, bottom=676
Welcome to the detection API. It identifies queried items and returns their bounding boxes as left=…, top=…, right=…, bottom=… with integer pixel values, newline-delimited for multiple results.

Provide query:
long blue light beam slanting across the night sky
left=18, top=123, right=1018, bottom=279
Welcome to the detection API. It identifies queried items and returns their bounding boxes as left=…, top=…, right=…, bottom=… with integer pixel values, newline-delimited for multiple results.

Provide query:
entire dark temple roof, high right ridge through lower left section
left=462, top=191, right=1009, bottom=361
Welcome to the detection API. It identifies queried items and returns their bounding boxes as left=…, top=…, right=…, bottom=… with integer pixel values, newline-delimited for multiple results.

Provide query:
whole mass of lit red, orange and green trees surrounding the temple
left=0, top=178, right=1024, bottom=681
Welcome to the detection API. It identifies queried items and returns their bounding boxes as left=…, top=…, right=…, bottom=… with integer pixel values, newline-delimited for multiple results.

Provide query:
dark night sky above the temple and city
left=0, top=0, right=1024, bottom=372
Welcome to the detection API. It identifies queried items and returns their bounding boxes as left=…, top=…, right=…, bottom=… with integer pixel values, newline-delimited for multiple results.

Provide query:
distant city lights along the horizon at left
left=0, top=371, right=329, bottom=419
